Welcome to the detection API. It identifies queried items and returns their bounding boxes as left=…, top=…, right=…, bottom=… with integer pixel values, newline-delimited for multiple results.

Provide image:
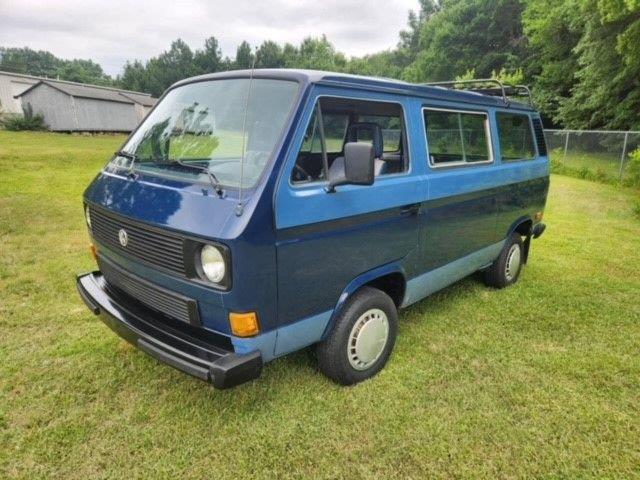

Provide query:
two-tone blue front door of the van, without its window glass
left=275, top=87, right=426, bottom=326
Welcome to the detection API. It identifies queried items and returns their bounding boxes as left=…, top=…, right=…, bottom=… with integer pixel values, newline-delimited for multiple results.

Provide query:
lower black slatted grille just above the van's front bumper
left=99, top=256, right=200, bottom=325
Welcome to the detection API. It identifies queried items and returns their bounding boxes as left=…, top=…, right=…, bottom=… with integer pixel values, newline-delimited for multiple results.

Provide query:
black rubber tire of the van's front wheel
left=316, top=287, right=398, bottom=385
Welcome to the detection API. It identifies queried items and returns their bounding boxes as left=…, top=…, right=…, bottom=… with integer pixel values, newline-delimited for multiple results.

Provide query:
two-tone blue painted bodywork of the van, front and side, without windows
left=85, top=70, right=549, bottom=372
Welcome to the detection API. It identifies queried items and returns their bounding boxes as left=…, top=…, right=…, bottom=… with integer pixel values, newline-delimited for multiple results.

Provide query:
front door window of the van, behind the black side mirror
left=291, top=97, right=408, bottom=184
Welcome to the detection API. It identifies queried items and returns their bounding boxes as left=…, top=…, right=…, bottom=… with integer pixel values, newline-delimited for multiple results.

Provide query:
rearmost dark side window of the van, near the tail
left=496, top=113, right=536, bottom=161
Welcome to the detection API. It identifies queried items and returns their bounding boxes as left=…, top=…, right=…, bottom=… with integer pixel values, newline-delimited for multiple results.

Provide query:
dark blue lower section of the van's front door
left=277, top=197, right=417, bottom=324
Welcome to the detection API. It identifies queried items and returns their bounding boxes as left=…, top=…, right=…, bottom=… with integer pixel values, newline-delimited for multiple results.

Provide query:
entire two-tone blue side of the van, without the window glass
left=274, top=87, right=549, bottom=348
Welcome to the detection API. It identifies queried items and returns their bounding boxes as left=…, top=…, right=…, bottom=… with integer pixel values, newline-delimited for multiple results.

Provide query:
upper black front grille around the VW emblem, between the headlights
left=89, top=207, right=185, bottom=277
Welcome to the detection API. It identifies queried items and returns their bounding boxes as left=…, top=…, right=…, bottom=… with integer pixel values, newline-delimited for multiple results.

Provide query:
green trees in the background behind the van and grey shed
left=0, top=0, right=640, bottom=130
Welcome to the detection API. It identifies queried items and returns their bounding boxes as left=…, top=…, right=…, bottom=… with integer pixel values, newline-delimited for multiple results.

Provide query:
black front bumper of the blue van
left=76, top=272, right=263, bottom=388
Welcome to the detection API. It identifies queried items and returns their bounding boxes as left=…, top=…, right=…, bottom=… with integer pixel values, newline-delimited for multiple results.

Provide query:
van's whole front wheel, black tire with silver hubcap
left=316, top=287, right=398, bottom=385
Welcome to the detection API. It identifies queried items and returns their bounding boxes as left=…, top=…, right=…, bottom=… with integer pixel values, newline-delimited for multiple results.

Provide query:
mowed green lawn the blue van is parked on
left=0, top=132, right=640, bottom=479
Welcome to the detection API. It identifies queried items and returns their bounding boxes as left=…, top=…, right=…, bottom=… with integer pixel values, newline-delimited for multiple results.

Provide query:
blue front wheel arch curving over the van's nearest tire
left=322, top=263, right=407, bottom=339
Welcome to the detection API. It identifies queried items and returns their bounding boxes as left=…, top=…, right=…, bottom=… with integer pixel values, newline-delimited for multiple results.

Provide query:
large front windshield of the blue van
left=108, top=78, right=298, bottom=187
